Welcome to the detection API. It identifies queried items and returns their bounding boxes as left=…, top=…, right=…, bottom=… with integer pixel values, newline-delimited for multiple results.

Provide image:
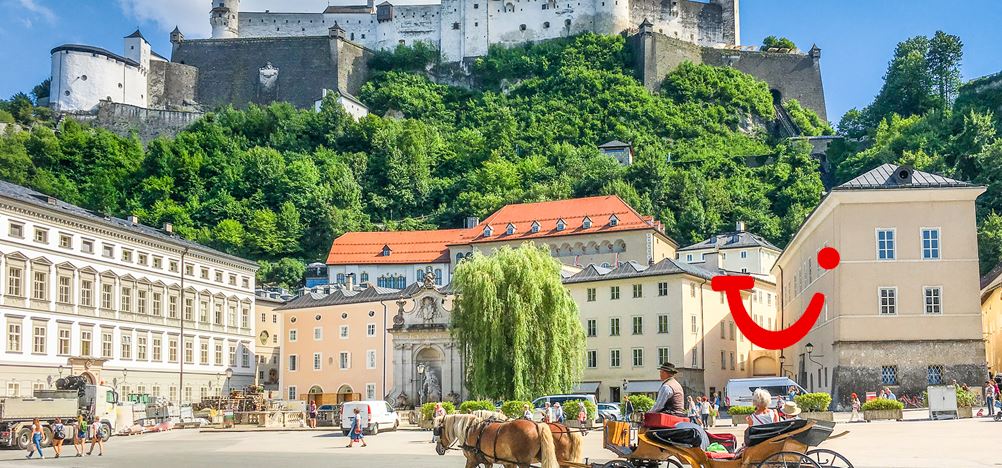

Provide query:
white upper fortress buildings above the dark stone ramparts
left=209, top=0, right=740, bottom=62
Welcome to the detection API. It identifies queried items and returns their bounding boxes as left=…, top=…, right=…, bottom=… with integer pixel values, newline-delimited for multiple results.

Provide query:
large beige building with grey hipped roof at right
left=774, top=164, right=986, bottom=403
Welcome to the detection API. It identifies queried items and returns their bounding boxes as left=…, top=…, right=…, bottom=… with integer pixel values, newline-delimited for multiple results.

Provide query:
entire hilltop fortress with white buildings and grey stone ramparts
left=49, top=0, right=826, bottom=139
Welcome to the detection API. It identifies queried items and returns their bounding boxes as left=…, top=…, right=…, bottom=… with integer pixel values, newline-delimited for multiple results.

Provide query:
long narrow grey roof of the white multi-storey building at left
left=0, top=180, right=258, bottom=271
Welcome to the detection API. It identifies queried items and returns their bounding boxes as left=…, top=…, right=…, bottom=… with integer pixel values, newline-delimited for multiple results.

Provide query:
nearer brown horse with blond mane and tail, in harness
left=436, top=415, right=560, bottom=468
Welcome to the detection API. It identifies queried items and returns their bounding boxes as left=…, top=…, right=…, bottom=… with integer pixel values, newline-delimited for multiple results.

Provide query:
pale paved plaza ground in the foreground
left=0, top=412, right=1002, bottom=468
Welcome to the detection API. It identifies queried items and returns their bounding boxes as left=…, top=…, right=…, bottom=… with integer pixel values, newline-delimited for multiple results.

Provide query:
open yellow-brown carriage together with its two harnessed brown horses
left=436, top=415, right=853, bottom=468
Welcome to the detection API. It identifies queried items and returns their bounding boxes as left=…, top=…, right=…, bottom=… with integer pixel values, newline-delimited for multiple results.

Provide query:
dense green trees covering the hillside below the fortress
left=0, top=34, right=823, bottom=286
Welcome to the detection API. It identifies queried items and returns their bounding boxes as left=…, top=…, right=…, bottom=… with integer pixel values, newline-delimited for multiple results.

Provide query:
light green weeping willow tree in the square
left=452, top=244, right=585, bottom=400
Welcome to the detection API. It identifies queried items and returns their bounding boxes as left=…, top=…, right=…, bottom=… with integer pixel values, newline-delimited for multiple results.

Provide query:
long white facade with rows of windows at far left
left=0, top=181, right=258, bottom=403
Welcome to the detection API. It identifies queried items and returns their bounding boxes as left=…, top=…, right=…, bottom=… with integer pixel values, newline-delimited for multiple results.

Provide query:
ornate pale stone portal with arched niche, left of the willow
left=389, top=274, right=466, bottom=406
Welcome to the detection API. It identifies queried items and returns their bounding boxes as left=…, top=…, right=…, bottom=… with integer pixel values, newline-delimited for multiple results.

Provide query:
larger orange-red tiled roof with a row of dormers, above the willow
left=462, top=195, right=662, bottom=244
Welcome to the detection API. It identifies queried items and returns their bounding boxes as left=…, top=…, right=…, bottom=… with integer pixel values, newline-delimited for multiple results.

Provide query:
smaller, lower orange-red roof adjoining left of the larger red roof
left=327, top=229, right=466, bottom=265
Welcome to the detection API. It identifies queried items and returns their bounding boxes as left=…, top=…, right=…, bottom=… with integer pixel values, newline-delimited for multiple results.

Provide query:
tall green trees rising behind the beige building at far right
left=829, top=31, right=1002, bottom=274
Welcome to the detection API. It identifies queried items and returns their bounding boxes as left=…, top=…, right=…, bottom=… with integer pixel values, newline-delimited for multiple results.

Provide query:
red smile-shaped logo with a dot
left=709, top=247, right=840, bottom=350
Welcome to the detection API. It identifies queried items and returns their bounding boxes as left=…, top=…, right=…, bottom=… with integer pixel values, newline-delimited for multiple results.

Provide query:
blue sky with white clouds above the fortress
left=0, top=0, right=1002, bottom=123
